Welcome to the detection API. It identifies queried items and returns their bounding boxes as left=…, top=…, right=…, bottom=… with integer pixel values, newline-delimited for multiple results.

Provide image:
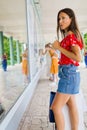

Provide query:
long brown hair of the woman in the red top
left=57, top=8, right=82, bottom=40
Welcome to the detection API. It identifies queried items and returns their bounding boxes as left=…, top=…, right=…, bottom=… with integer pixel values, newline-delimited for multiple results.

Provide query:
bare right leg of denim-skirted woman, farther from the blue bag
left=67, top=95, right=79, bottom=130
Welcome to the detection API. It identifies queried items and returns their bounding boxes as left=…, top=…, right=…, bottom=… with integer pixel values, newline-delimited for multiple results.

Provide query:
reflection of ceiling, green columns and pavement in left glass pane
left=0, top=0, right=29, bottom=121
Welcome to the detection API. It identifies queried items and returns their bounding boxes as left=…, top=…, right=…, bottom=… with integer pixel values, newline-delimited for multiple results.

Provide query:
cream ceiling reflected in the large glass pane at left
left=0, top=0, right=27, bottom=42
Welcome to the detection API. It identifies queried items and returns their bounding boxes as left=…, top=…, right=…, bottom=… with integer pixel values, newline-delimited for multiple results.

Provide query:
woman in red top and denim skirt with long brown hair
left=51, top=8, right=83, bottom=130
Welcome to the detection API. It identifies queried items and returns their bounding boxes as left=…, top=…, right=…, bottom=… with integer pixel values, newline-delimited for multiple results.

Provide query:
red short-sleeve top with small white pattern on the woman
left=58, top=34, right=83, bottom=66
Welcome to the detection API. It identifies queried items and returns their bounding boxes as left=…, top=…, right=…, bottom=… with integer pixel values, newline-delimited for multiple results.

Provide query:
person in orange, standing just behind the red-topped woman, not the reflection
left=42, top=43, right=58, bottom=82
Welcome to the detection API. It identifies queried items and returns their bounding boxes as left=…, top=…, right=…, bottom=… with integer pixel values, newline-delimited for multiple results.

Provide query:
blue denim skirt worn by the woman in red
left=57, top=64, right=80, bottom=94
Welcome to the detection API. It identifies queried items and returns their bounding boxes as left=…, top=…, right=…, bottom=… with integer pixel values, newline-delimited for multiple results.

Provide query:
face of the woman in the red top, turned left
left=59, top=12, right=71, bottom=30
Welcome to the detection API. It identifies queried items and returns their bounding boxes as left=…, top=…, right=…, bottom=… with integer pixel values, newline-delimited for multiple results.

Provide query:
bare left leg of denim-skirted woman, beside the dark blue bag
left=51, top=93, right=70, bottom=130
